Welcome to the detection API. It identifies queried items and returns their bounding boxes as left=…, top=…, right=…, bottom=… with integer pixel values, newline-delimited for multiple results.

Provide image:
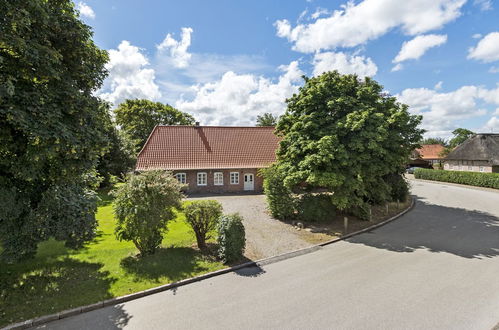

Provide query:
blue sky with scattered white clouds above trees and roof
left=76, top=0, right=499, bottom=137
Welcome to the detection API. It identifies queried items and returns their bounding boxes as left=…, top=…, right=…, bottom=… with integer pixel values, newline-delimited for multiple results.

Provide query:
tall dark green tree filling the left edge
left=0, top=0, right=109, bottom=260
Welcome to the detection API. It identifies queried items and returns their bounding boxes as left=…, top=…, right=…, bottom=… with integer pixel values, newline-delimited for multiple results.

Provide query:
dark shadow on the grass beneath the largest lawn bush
left=120, top=247, right=217, bottom=283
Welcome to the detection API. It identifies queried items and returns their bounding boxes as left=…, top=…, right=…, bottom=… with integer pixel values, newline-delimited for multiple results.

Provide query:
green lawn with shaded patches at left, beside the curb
left=0, top=189, right=224, bottom=326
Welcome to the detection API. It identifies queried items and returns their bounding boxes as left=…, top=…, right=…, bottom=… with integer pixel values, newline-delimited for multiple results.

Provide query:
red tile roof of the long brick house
left=135, top=126, right=279, bottom=171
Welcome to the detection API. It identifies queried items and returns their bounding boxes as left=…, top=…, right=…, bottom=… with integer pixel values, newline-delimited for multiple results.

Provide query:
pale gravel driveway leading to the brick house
left=187, top=195, right=313, bottom=260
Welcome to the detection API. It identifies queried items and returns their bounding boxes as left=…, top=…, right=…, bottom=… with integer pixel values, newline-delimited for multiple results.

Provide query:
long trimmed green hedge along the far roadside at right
left=414, top=168, right=499, bottom=189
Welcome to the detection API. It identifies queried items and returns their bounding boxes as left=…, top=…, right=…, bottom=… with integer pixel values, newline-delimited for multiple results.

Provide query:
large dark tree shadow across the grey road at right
left=348, top=198, right=499, bottom=259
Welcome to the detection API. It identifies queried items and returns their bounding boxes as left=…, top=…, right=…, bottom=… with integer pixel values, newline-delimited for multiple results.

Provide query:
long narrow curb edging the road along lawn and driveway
left=2, top=197, right=416, bottom=330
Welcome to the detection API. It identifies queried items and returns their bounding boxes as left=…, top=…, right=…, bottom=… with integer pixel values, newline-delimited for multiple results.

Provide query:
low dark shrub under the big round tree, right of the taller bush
left=297, top=194, right=336, bottom=222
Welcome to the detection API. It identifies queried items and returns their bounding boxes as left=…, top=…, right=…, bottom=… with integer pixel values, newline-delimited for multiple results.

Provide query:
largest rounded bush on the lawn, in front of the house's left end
left=114, top=171, right=183, bottom=255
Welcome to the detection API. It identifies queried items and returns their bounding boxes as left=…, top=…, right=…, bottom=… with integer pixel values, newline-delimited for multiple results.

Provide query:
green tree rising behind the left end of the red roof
left=115, top=99, right=194, bottom=152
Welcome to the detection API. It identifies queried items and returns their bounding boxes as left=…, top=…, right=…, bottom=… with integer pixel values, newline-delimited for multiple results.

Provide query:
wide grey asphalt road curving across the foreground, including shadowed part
left=36, top=182, right=499, bottom=329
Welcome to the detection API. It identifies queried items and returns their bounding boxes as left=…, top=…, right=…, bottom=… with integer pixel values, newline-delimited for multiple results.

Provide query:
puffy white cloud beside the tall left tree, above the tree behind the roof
left=99, top=40, right=161, bottom=105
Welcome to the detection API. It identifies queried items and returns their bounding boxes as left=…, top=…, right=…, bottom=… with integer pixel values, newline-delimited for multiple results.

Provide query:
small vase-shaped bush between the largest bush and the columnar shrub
left=184, top=200, right=222, bottom=250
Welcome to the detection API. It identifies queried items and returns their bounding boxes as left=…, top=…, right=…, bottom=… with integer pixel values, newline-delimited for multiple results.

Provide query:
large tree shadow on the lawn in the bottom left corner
left=0, top=258, right=115, bottom=326
